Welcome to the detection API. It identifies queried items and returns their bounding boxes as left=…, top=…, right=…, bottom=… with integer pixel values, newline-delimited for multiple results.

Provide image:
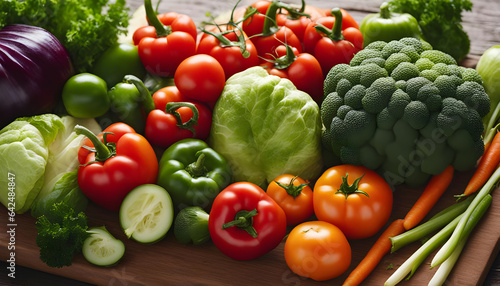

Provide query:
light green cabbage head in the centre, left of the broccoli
left=209, top=67, right=323, bottom=188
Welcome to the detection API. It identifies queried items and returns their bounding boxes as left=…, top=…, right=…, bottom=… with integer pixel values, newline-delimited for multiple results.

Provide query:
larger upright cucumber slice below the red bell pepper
left=120, top=184, right=174, bottom=243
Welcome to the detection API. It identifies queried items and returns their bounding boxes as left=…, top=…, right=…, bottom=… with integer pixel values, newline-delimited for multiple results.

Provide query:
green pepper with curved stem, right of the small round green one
left=99, top=75, right=155, bottom=134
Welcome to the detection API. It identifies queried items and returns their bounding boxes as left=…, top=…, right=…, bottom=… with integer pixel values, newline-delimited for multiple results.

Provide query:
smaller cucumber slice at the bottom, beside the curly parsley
left=82, top=226, right=125, bottom=266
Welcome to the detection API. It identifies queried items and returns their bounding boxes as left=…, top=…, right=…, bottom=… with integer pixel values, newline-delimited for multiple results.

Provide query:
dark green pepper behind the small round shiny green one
left=91, top=43, right=146, bottom=88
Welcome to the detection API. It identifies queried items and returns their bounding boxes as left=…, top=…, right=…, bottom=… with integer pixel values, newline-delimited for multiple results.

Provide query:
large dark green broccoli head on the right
left=321, top=38, right=490, bottom=186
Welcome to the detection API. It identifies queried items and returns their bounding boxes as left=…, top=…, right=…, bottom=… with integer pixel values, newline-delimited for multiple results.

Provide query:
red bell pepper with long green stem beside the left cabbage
left=75, top=123, right=158, bottom=211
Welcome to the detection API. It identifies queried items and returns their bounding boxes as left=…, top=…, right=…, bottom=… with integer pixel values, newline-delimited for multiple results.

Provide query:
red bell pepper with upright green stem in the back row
left=133, top=0, right=196, bottom=77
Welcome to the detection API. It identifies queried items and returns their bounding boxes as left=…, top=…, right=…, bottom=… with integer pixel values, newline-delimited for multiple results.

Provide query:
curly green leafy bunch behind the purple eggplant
left=0, top=0, right=129, bottom=72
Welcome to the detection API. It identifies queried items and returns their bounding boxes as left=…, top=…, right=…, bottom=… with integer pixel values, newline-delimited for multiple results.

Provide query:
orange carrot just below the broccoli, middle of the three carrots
left=404, top=165, right=455, bottom=230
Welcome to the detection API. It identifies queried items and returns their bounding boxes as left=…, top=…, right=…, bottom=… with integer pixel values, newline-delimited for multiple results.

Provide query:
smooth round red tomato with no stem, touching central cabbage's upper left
left=174, top=54, right=226, bottom=102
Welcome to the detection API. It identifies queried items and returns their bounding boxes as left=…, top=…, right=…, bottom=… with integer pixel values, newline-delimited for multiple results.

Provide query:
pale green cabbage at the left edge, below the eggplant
left=0, top=114, right=100, bottom=213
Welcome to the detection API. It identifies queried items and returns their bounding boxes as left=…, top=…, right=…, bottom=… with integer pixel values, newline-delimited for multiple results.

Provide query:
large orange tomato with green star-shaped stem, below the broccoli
left=313, top=165, right=393, bottom=239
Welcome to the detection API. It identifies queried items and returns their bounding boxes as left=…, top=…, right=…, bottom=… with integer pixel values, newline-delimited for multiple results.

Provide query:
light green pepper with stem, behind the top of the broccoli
left=359, top=2, right=422, bottom=47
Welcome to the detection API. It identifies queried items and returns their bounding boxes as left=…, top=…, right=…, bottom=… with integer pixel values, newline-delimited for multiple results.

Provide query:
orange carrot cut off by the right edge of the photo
left=463, top=132, right=500, bottom=196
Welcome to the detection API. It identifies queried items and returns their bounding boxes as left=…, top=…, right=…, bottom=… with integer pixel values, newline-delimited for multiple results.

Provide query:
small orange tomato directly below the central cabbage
left=266, top=174, right=314, bottom=225
